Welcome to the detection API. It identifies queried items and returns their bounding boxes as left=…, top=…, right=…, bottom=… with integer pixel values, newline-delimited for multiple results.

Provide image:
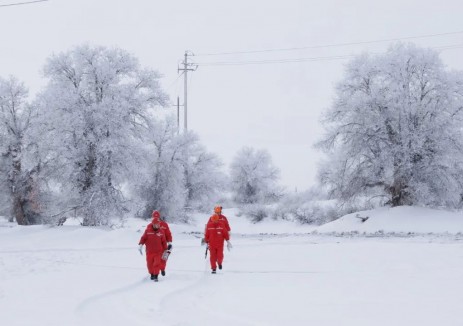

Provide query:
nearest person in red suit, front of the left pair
left=138, top=218, right=167, bottom=282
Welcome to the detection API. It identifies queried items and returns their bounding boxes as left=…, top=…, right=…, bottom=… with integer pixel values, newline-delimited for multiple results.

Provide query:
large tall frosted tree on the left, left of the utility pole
left=40, top=46, right=167, bottom=225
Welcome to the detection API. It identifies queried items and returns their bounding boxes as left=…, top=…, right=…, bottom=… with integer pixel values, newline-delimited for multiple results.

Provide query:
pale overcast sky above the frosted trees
left=0, top=0, right=463, bottom=190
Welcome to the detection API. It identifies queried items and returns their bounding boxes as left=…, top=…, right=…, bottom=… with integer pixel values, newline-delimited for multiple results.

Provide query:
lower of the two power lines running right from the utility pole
left=196, top=44, right=463, bottom=67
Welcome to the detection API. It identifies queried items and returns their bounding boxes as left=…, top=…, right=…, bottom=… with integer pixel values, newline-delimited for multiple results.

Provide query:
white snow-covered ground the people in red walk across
left=0, top=208, right=463, bottom=326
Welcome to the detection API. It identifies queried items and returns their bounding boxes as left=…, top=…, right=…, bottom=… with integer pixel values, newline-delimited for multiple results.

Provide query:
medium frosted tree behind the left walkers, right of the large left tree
left=137, top=118, right=225, bottom=221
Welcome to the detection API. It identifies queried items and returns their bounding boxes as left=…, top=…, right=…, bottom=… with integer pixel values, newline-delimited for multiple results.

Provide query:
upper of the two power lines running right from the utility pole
left=195, top=31, right=463, bottom=56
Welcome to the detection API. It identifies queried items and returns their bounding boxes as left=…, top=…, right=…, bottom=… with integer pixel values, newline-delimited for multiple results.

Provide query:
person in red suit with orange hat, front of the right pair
left=204, top=214, right=232, bottom=274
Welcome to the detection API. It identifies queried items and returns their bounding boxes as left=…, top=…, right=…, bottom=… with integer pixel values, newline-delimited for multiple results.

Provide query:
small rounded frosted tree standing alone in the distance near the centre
left=230, top=147, right=282, bottom=204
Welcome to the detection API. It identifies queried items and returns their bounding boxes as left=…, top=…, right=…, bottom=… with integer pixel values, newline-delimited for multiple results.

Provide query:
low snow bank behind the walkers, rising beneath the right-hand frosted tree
left=178, top=206, right=463, bottom=235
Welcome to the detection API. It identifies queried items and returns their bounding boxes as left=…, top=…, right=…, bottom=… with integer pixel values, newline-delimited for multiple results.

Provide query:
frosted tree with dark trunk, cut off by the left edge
left=0, top=77, right=41, bottom=225
